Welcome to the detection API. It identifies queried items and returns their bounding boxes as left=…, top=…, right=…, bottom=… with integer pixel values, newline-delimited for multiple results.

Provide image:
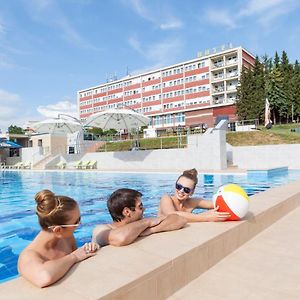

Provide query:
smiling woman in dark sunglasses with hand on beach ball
left=158, top=169, right=230, bottom=222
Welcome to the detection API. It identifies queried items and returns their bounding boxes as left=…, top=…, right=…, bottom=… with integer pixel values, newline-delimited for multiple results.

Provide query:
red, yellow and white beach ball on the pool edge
left=213, top=183, right=250, bottom=221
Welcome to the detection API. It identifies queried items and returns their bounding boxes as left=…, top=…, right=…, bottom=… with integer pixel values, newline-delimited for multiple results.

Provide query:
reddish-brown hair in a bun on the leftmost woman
left=35, top=190, right=77, bottom=229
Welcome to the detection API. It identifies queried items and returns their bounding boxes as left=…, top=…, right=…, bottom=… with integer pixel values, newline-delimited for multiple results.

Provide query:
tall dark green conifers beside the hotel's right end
left=236, top=51, right=300, bottom=124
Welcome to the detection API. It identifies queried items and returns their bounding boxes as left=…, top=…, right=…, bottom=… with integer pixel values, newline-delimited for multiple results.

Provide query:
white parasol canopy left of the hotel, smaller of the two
left=31, top=117, right=82, bottom=134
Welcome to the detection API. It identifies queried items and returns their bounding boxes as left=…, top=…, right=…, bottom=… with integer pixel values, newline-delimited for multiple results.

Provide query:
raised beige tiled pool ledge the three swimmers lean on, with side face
left=0, top=181, right=300, bottom=300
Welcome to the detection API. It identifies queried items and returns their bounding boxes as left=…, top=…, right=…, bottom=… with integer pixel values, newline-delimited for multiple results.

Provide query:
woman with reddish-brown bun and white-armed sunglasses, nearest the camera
left=18, top=190, right=98, bottom=287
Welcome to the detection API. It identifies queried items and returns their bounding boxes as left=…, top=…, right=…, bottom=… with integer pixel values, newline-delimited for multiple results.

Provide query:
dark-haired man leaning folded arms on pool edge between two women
left=93, top=188, right=186, bottom=246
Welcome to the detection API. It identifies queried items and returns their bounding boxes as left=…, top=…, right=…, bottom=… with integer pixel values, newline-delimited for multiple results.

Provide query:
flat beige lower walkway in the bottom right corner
left=168, top=208, right=300, bottom=300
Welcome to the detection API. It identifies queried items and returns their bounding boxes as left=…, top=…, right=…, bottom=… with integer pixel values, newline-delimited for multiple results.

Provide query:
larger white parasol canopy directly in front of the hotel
left=84, top=109, right=150, bottom=131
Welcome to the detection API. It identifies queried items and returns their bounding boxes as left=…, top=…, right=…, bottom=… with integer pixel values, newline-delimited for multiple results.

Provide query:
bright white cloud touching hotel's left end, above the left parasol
left=37, top=99, right=78, bottom=118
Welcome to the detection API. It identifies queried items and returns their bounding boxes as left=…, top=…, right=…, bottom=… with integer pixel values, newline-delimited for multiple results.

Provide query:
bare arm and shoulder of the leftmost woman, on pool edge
left=18, top=243, right=97, bottom=287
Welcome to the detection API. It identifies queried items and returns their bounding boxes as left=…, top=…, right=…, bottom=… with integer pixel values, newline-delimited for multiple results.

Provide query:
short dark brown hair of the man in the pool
left=107, top=189, right=142, bottom=222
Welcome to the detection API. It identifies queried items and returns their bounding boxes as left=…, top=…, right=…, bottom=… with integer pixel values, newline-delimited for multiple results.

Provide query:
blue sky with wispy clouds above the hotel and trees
left=0, top=0, right=300, bottom=131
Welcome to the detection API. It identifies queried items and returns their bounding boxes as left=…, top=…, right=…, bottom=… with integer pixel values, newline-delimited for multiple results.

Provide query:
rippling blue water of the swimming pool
left=0, top=171, right=300, bottom=282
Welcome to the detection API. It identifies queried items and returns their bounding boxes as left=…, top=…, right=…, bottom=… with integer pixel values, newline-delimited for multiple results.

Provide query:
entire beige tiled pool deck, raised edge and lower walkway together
left=0, top=181, right=300, bottom=300
